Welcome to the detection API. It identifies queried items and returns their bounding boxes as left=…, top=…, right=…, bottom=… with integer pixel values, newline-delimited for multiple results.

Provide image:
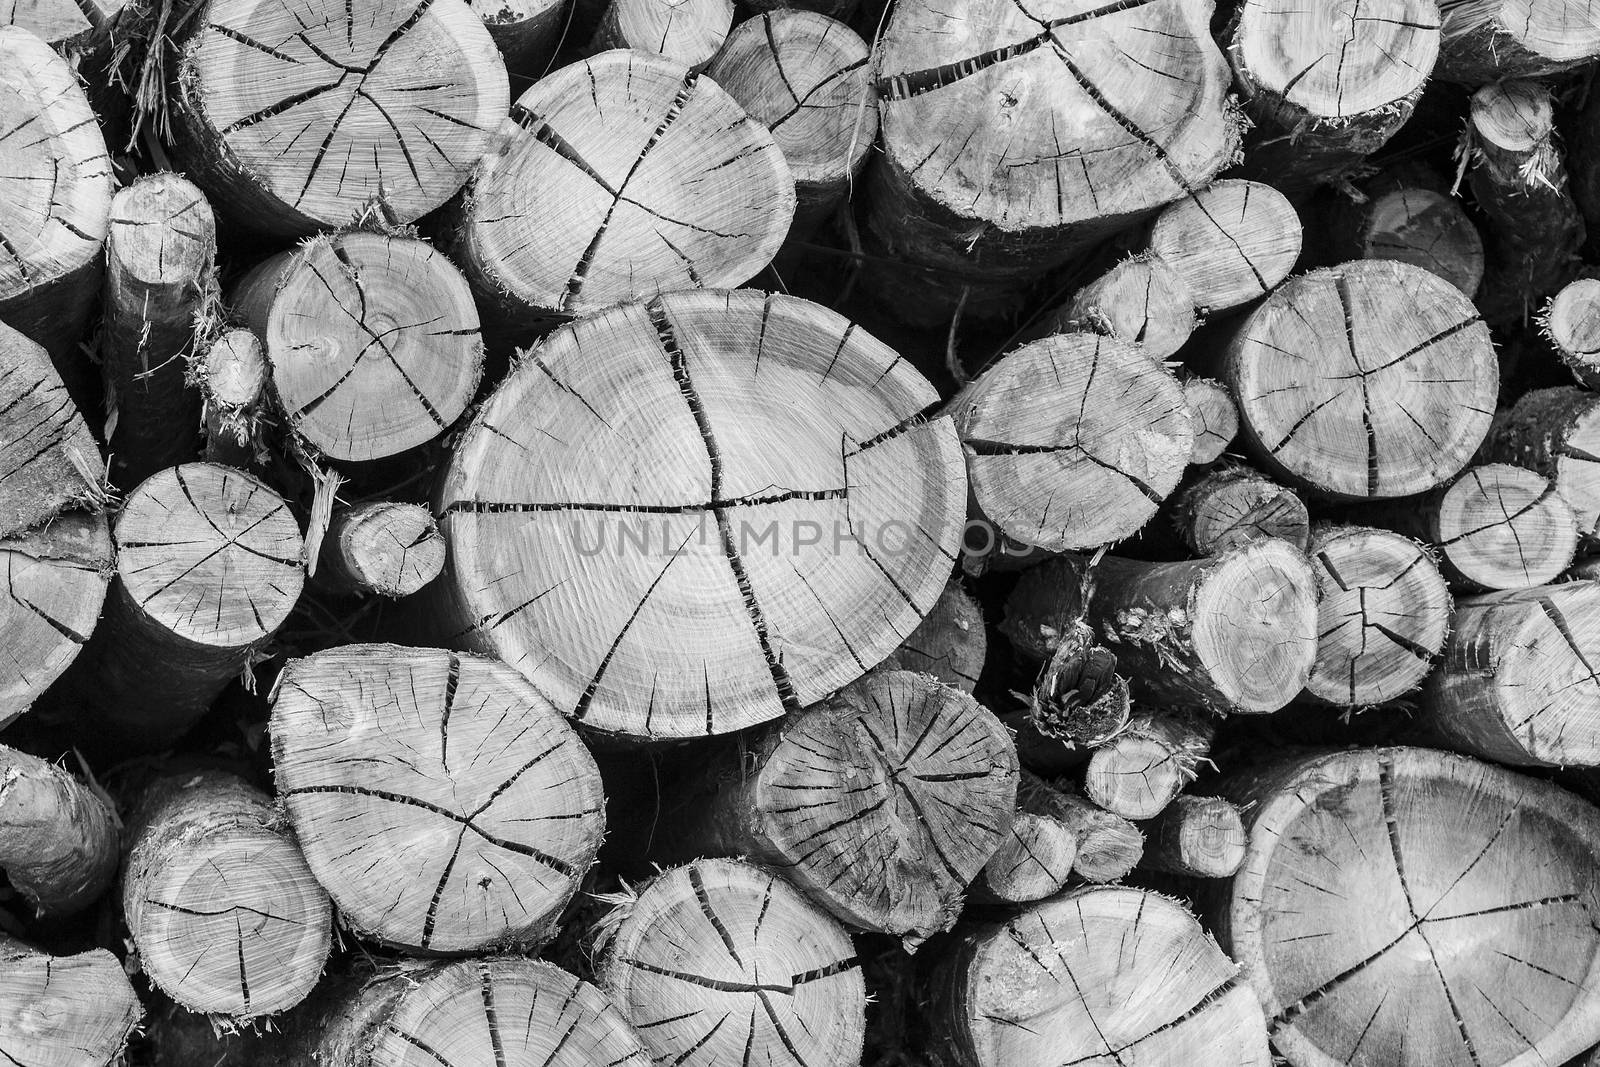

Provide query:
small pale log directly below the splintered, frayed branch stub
left=1083, top=712, right=1213, bottom=819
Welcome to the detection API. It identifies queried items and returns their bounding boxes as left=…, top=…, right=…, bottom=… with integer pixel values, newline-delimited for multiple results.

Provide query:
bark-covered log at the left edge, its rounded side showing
left=0, top=745, right=122, bottom=921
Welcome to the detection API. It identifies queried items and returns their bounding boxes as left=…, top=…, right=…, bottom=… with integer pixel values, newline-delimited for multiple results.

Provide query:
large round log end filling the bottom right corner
left=1214, top=749, right=1600, bottom=1067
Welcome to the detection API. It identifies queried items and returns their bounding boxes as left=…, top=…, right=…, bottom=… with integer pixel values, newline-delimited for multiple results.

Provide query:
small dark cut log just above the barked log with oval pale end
left=1173, top=467, right=1310, bottom=555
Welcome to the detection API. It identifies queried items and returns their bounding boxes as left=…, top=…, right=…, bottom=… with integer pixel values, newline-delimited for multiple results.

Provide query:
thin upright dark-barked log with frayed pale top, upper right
left=1466, top=80, right=1584, bottom=325
